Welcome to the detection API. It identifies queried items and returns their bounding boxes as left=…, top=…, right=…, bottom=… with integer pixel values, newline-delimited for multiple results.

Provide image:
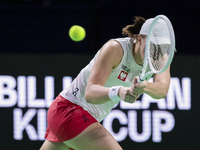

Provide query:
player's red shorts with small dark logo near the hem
left=45, top=95, right=97, bottom=142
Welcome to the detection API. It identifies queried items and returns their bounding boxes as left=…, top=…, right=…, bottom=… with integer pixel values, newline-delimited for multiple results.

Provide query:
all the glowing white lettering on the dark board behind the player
left=0, top=76, right=188, bottom=142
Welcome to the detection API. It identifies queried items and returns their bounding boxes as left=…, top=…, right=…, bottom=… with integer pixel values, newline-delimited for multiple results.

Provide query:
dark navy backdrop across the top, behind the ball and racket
left=0, top=0, right=200, bottom=55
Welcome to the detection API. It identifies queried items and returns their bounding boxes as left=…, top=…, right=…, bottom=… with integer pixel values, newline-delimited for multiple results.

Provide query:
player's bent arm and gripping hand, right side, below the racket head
left=134, top=67, right=170, bottom=99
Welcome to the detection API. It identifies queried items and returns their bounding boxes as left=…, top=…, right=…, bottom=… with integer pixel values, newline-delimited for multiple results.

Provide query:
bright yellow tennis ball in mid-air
left=69, top=25, right=86, bottom=42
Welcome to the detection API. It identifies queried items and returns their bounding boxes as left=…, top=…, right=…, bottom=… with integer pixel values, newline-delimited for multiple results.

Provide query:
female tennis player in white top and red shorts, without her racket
left=40, top=17, right=170, bottom=150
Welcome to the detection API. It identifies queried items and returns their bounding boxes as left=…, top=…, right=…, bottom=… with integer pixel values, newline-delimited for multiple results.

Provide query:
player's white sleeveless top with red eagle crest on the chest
left=60, top=37, right=142, bottom=122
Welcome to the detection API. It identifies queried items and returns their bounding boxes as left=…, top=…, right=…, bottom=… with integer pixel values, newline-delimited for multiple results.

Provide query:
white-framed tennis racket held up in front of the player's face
left=138, top=15, right=175, bottom=83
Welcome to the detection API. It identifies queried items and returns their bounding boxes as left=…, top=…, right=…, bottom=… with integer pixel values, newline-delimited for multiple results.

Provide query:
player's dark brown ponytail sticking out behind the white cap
left=122, top=16, right=145, bottom=37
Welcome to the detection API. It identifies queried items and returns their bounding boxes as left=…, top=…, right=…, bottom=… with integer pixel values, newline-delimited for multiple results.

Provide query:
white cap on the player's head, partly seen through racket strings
left=140, top=18, right=171, bottom=44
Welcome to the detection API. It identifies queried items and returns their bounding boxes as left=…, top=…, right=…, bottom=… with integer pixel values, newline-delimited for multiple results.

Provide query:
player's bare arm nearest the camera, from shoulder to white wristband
left=85, top=40, right=123, bottom=104
